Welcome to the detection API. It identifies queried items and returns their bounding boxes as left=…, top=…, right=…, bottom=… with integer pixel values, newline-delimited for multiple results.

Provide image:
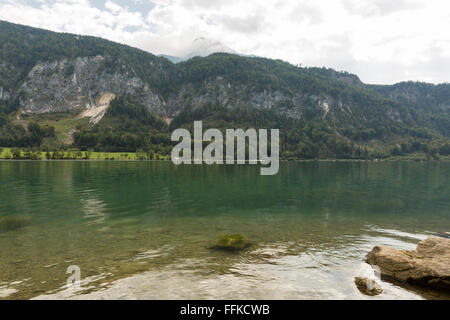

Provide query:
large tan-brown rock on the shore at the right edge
left=365, top=237, right=450, bottom=290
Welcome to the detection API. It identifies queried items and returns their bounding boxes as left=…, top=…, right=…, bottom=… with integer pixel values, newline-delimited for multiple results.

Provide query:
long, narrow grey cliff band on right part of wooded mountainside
left=164, top=76, right=415, bottom=131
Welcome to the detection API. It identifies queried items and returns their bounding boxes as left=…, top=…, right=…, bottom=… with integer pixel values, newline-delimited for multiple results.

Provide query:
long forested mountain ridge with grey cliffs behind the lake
left=0, top=22, right=450, bottom=159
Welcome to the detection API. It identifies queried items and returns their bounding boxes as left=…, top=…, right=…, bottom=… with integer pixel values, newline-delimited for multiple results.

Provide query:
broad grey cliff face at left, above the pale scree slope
left=18, top=56, right=163, bottom=120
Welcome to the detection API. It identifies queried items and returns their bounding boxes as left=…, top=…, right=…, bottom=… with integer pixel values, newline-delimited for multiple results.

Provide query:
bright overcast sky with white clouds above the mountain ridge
left=0, top=0, right=450, bottom=84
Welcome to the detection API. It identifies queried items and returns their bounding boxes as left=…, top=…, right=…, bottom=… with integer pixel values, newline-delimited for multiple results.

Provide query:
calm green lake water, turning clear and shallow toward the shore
left=0, top=161, right=450, bottom=299
